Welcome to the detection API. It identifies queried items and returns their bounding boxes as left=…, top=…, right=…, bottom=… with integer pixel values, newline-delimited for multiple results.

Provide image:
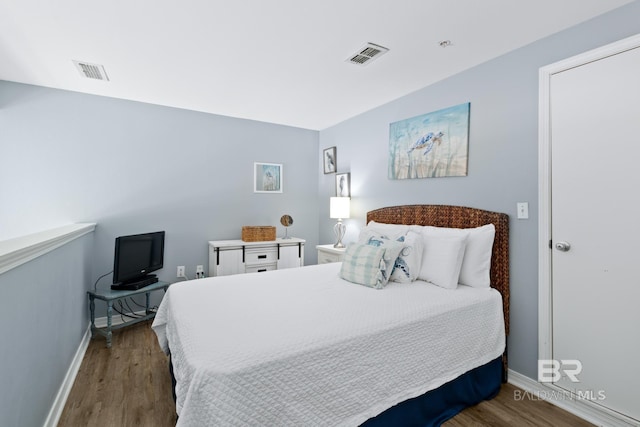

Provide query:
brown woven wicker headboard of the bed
left=367, top=205, right=509, bottom=335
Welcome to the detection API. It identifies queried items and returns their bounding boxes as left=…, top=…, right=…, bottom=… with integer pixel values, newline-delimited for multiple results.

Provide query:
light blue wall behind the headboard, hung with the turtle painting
left=319, top=1, right=640, bottom=378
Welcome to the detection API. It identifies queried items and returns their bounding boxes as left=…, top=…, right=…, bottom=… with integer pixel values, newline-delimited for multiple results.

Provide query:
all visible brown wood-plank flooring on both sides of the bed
left=58, top=322, right=592, bottom=427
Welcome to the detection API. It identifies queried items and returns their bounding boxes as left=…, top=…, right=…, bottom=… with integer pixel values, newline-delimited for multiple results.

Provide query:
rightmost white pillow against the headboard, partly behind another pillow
left=422, top=224, right=496, bottom=288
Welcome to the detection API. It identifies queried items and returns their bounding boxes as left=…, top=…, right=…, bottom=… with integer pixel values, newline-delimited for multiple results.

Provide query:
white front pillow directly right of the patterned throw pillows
left=418, top=233, right=467, bottom=289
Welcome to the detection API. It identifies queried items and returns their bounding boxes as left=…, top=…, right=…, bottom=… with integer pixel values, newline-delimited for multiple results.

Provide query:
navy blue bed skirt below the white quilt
left=362, top=357, right=502, bottom=427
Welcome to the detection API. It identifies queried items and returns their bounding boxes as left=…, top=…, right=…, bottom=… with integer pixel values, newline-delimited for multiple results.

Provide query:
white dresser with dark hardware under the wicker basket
left=209, top=237, right=305, bottom=276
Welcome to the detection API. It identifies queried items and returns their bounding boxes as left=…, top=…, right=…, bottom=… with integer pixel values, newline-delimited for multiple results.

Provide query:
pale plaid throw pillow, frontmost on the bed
left=340, top=243, right=388, bottom=289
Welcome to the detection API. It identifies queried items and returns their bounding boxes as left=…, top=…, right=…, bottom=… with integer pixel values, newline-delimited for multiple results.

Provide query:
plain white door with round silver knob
left=549, top=41, right=640, bottom=420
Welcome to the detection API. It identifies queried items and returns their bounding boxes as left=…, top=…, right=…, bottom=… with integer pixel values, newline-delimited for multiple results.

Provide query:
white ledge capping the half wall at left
left=0, top=223, right=96, bottom=274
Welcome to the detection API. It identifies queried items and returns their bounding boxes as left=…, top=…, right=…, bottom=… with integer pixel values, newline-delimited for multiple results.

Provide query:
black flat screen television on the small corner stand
left=111, top=231, right=164, bottom=289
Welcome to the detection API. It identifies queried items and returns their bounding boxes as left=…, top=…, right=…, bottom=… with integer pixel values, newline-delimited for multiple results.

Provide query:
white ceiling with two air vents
left=0, top=0, right=632, bottom=130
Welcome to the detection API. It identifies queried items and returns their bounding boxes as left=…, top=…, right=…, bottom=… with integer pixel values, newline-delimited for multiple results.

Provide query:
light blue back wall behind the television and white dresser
left=0, top=81, right=318, bottom=316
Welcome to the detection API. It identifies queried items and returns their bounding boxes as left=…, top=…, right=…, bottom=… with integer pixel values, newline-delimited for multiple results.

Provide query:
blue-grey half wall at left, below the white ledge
left=0, top=233, right=94, bottom=427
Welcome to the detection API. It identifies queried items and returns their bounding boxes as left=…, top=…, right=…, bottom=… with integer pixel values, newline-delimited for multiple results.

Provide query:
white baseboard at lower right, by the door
left=509, top=369, right=640, bottom=427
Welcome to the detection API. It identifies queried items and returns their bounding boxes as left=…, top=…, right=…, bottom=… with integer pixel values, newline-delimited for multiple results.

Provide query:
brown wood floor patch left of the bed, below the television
left=58, top=321, right=175, bottom=427
